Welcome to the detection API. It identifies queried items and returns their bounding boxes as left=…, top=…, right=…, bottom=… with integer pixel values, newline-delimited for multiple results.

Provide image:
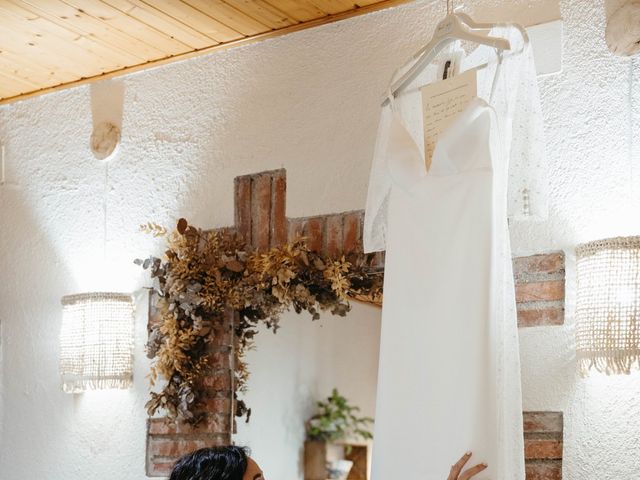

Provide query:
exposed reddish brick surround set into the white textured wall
left=146, top=169, right=565, bottom=480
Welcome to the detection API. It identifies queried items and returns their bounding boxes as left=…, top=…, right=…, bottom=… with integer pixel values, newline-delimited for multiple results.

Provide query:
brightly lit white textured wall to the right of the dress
left=512, top=1, right=640, bottom=480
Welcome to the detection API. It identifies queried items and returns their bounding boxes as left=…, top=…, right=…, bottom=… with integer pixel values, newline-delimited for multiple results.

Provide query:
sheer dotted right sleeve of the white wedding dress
left=509, top=44, right=548, bottom=220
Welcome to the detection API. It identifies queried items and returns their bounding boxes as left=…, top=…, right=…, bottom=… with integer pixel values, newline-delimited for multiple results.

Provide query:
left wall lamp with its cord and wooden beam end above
left=60, top=90, right=134, bottom=393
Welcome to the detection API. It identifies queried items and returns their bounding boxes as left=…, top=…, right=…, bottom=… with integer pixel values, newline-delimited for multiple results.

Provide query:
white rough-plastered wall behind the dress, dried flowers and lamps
left=0, top=0, right=640, bottom=480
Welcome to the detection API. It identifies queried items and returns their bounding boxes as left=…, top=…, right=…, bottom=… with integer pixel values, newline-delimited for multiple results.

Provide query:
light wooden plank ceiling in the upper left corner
left=0, top=0, right=407, bottom=103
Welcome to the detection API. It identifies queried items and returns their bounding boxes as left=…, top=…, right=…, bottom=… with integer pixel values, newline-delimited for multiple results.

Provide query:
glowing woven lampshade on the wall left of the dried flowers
left=60, top=292, right=134, bottom=393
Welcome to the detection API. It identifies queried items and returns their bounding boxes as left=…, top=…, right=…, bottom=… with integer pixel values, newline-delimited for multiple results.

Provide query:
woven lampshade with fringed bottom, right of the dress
left=576, top=237, right=640, bottom=375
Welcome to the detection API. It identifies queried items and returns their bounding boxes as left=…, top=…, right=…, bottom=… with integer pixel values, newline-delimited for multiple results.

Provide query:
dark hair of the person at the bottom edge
left=169, top=446, right=249, bottom=480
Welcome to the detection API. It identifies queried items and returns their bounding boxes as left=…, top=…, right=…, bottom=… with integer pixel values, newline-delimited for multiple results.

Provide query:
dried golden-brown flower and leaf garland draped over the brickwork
left=135, top=219, right=382, bottom=423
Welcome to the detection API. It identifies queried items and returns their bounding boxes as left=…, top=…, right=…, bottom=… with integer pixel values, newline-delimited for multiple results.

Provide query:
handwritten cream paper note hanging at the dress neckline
left=420, top=69, right=478, bottom=170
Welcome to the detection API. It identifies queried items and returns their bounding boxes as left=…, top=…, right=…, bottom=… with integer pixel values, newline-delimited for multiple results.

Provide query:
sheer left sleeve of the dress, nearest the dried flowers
left=363, top=104, right=393, bottom=253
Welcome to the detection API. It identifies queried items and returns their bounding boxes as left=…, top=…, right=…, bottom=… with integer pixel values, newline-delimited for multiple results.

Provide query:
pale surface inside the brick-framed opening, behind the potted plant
left=235, top=310, right=380, bottom=479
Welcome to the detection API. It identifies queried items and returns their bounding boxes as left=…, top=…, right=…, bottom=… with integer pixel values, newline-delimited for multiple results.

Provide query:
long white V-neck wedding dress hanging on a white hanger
left=364, top=27, right=544, bottom=480
